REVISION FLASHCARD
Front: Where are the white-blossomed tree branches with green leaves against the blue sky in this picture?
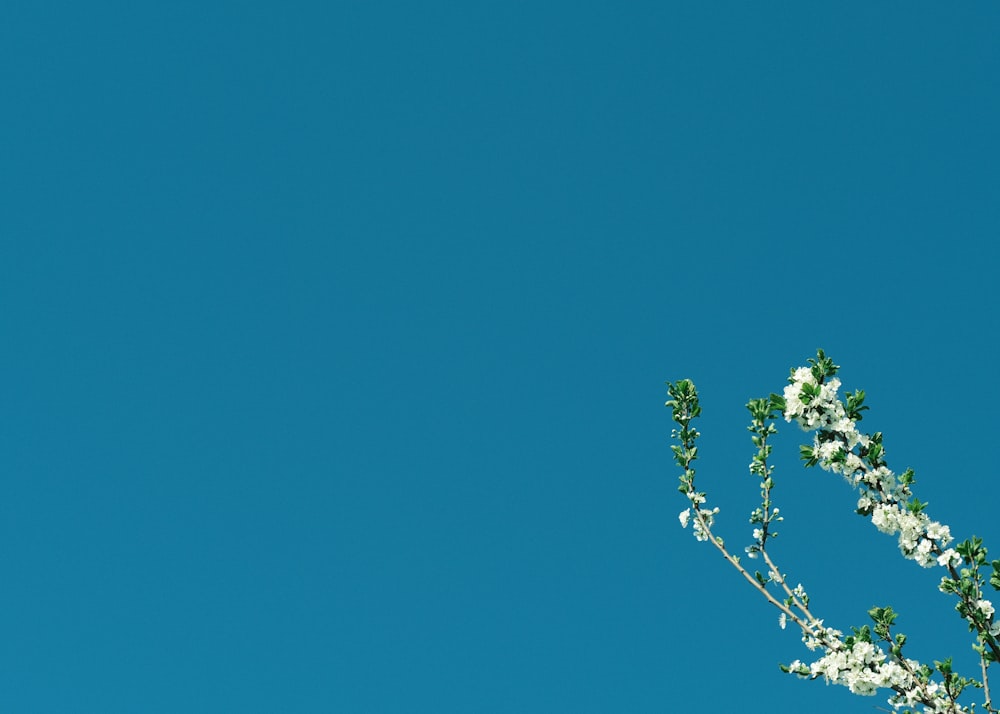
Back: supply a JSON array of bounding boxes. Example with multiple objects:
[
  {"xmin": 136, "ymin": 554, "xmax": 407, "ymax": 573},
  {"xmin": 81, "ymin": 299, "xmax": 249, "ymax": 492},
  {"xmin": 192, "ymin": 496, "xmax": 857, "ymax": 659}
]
[{"xmin": 666, "ymin": 350, "xmax": 1000, "ymax": 714}]
